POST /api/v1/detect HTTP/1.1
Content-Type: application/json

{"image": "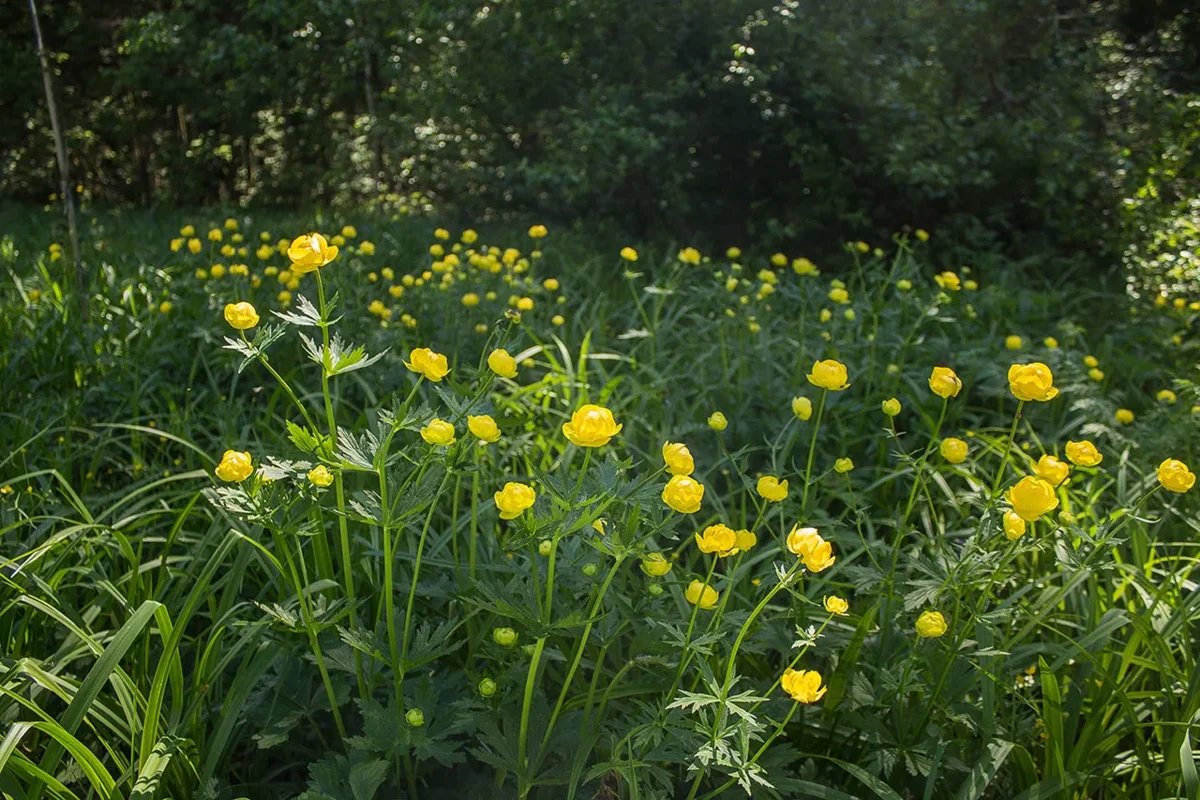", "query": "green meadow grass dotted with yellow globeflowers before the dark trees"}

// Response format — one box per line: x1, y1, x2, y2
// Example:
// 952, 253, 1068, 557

0, 206, 1200, 800
